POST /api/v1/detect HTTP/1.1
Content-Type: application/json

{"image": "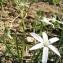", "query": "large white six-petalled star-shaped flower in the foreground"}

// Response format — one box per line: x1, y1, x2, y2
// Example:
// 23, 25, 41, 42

30, 32, 61, 63
